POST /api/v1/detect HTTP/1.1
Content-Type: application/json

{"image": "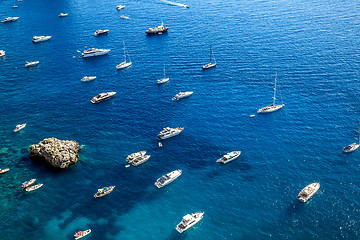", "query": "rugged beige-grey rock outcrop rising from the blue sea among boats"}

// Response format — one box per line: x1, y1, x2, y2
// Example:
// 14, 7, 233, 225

29, 138, 81, 168
